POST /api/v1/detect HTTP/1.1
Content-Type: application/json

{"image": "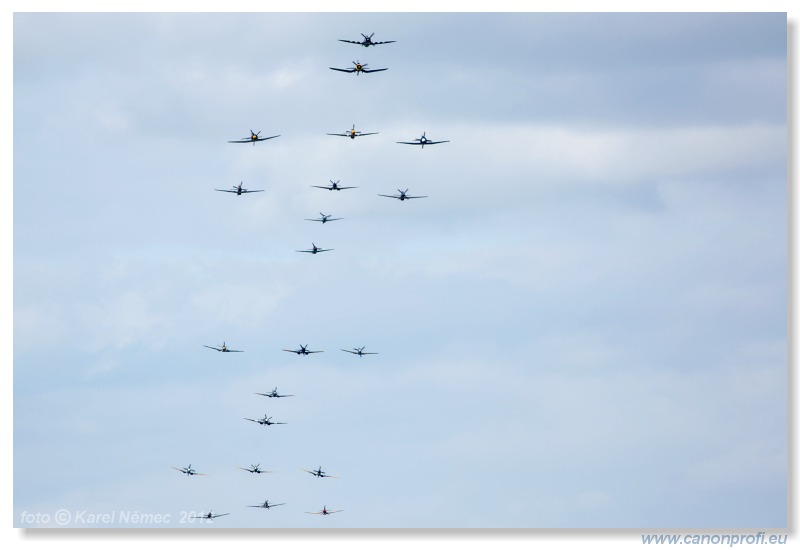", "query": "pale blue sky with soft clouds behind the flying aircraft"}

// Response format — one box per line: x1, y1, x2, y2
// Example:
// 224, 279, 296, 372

13, 6, 789, 529
